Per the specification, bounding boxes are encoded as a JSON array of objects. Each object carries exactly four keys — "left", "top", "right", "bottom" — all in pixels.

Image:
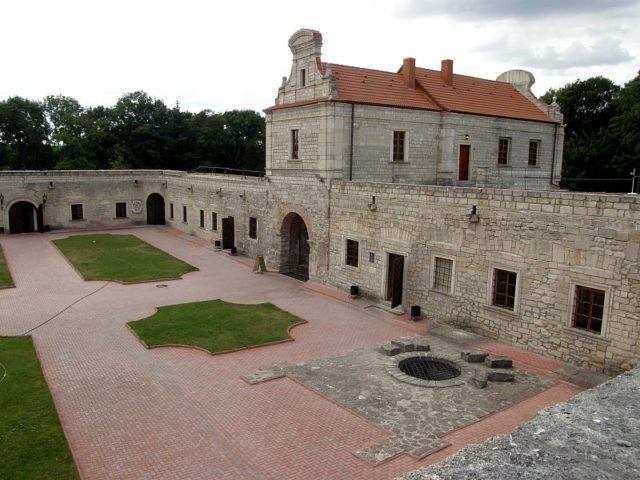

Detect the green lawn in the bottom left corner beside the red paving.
[{"left": 0, "top": 337, "right": 79, "bottom": 479}]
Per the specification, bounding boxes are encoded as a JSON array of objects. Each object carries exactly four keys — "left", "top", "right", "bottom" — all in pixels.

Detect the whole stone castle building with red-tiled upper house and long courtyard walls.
[{"left": 0, "top": 30, "right": 640, "bottom": 374}]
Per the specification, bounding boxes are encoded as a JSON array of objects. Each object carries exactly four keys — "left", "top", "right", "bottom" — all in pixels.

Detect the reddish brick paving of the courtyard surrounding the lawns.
[{"left": 0, "top": 227, "right": 577, "bottom": 480}]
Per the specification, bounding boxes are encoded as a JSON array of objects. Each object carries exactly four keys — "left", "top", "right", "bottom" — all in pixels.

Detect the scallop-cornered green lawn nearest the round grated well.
[{"left": 129, "top": 300, "right": 305, "bottom": 353}]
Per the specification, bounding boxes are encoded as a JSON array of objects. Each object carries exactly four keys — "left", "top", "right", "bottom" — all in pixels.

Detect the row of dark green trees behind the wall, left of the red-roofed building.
[{"left": 0, "top": 92, "right": 265, "bottom": 170}]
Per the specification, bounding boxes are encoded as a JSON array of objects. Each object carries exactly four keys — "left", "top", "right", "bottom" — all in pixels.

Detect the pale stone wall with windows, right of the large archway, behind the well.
[{"left": 328, "top": 182, "right": 640, "bottom": 373}]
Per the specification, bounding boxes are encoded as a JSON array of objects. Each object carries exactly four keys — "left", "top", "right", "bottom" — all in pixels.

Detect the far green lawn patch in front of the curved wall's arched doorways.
[{"left": 53, "top": 234, "right": 197, "bottom": 283}]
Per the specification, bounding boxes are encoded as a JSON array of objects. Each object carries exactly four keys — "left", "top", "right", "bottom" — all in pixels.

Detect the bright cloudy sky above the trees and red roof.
[{"left": 0, "top": 0, "right": 640, "bottom": 111}]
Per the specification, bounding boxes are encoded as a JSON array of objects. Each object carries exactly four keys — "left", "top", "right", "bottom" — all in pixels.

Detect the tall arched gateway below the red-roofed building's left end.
[{"left": 280, "top": 212, "right": 309, "bottom": 280}]
